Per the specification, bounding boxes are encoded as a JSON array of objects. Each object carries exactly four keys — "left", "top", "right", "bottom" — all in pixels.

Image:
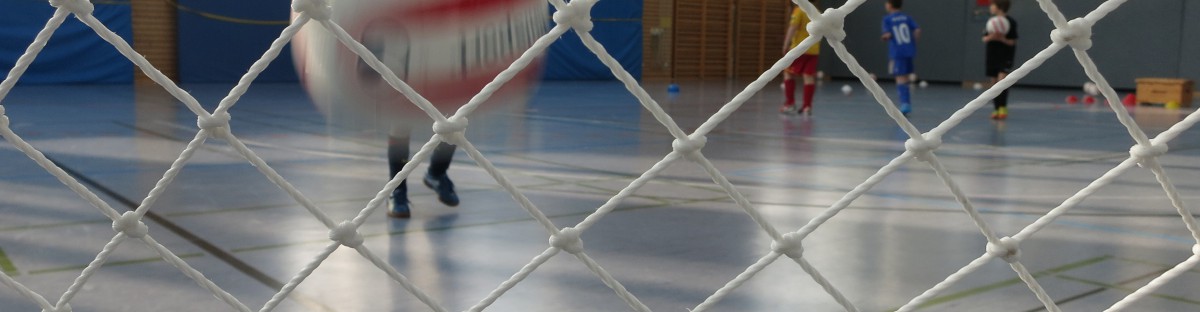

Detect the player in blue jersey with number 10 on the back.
[{"left": 883, "top": 0, "right": 920, "bottom": 115}]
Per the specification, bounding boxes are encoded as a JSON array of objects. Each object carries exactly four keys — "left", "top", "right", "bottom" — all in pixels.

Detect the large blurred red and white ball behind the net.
[{"left": 292, "top": 0, "right": 548, "bottom": 122}]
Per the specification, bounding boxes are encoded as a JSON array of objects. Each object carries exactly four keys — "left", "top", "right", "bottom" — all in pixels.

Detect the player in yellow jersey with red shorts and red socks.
[{"left": 779, "top": 0, "right": 821, "bottom": 115}]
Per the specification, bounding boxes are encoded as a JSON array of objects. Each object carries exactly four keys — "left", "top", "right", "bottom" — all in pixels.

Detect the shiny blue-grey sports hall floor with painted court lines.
[{"left": 0, "top": 82, "right": 1200, "bottom": 312}]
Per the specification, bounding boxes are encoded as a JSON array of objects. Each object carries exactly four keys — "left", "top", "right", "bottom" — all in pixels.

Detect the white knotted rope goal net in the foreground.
[{"left": 0, "top": 0, "right": 1200, "bottom": 312}]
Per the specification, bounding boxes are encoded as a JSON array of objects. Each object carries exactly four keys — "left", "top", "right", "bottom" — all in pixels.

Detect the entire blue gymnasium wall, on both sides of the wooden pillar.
[{"left": 0, "top": 0, "right": 643, "bottom": 83}]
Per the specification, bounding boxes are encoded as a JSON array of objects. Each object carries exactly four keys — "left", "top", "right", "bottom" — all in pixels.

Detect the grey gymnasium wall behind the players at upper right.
[{"left": 821, "top": 0, "right": 1200, "bottom": 89}]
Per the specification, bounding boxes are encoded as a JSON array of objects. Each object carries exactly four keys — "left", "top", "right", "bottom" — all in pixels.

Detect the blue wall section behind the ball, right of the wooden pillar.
[{"left": 168, "top": 0, "right": 642, "bottom": 83}]
